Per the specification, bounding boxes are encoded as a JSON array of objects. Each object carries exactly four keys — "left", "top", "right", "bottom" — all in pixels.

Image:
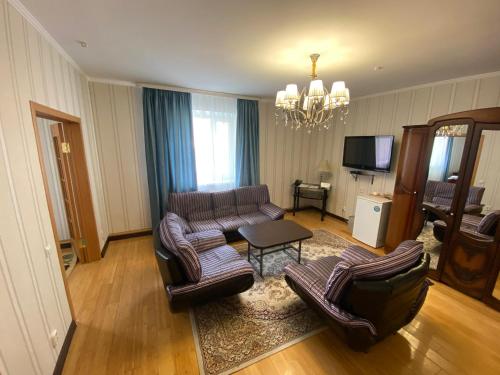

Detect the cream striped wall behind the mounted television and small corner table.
[{"left": 260, "top": 72, "right": 500, "bottom": 217}]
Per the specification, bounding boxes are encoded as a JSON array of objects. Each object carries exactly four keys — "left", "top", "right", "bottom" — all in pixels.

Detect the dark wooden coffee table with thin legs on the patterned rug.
[{"left": 238, "top": 220, "right": 313, "bottom": 276}]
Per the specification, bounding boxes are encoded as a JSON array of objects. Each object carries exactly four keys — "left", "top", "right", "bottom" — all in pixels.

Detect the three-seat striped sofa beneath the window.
[{"left": 168, "top": 185, "right": 285, "bottom": 240}]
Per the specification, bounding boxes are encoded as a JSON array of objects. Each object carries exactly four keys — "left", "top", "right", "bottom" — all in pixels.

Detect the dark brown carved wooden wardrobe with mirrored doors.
[{"left": 386, "top": 108, "right": 500, "bottom": 309}]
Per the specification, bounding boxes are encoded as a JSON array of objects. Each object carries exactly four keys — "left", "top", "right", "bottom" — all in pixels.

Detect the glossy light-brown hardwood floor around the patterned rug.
[{"left": 64, "top": 211, "right": 500, "bottom": 375}]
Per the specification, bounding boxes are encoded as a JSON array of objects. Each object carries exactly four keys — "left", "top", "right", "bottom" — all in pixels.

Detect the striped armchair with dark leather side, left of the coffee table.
[{"left": 153, "top": 212, "right": 254, "bottom": 312}]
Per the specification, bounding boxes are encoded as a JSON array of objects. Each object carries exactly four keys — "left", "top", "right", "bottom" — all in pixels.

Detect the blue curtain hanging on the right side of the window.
[{"left": 235, "top": 99, "right": 259, "bottom": 186}]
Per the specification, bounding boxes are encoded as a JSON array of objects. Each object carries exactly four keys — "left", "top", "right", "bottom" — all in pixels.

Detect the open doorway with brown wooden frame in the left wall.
[{"left": 31, "top": 102, "right": 101, "bottom": 279}]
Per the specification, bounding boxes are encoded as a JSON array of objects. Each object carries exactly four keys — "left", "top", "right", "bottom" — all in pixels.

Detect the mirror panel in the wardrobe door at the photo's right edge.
[{"left": 460, "top": 130, "right": 500, "bottom": 241}]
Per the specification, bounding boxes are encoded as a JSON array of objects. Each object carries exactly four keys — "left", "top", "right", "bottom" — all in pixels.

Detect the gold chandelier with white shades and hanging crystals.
[{"left": 275, "top": 53, "right": 349, "bottom": 133}]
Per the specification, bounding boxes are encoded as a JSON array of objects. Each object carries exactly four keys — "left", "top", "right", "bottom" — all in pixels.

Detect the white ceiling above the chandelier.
[{"left": 21, "top": 0, "right": 500, "bottom": 97}]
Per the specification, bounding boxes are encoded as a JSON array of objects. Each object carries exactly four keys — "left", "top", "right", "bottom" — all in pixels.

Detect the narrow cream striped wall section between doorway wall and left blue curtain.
[{"left": 90, "top": 82, "right": 151, "bottom": 233}]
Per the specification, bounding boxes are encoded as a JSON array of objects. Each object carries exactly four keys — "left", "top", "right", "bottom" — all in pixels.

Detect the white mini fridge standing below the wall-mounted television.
[{"left": 352, "top": 195, "right": 392, "bottom": 247}]
